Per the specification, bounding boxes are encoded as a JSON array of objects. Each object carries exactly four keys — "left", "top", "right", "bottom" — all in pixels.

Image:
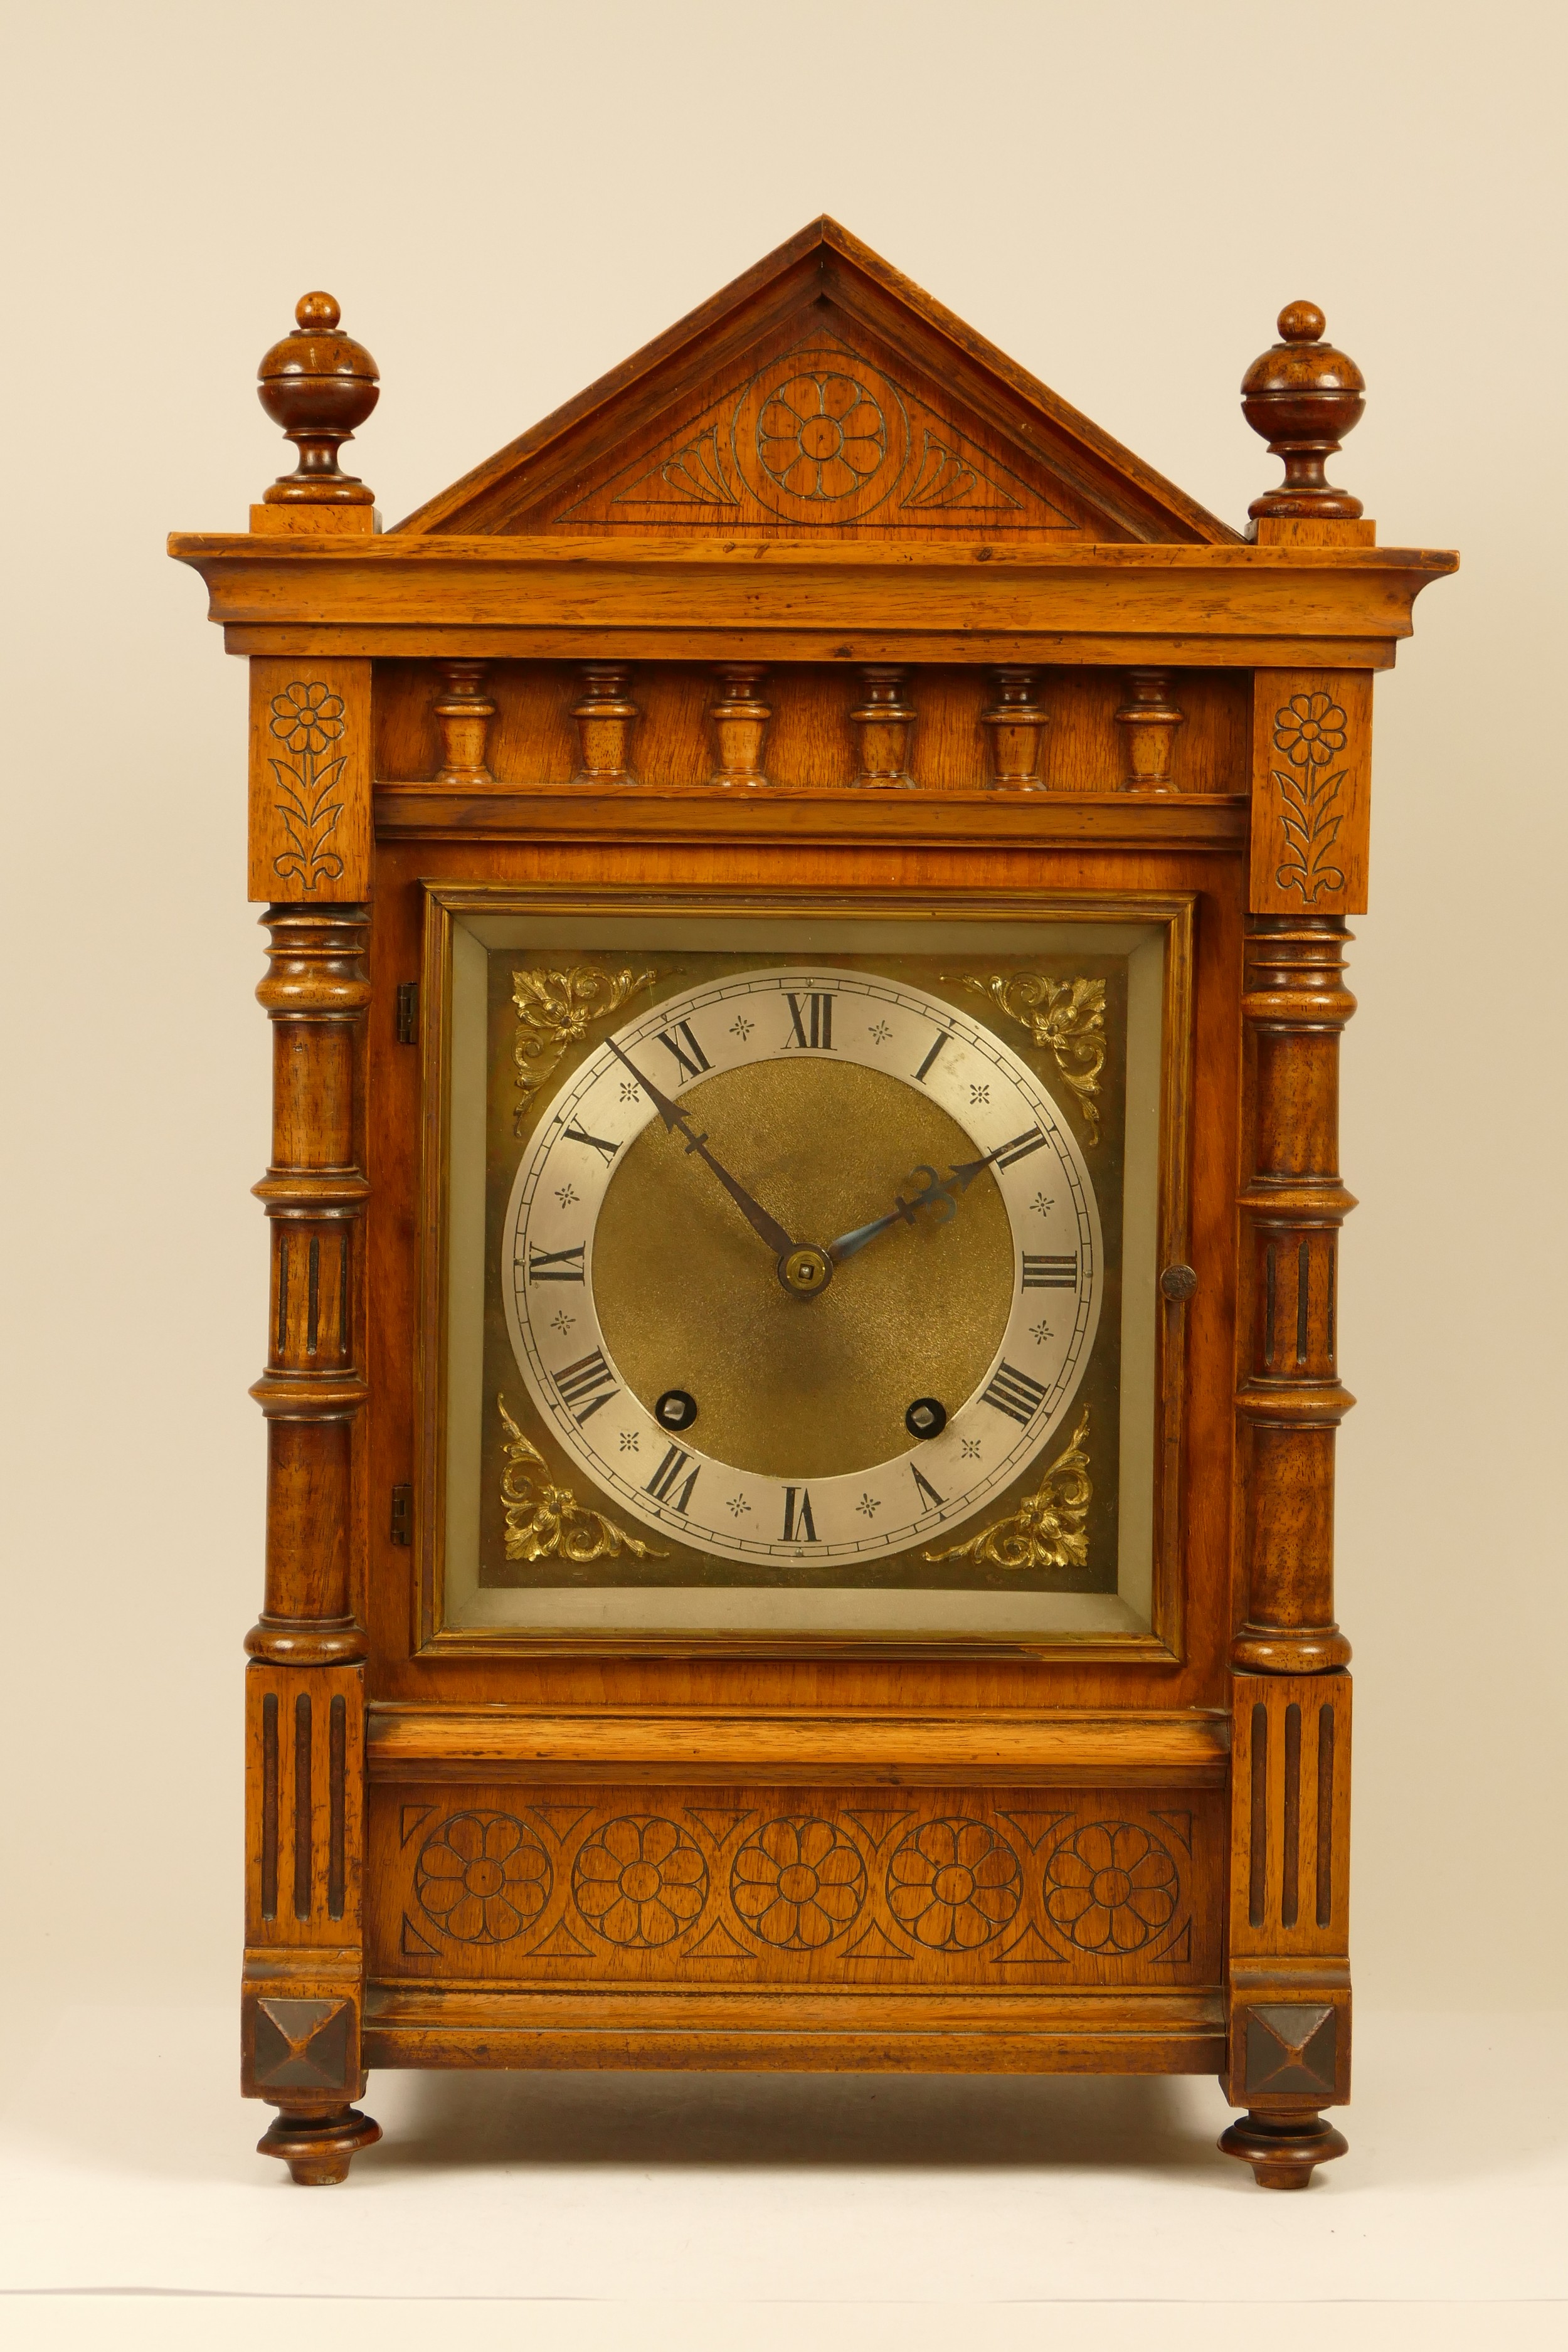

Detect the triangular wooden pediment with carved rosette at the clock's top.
[{"left": 400, "top": 219, "right": 1237, "bottom": 543}]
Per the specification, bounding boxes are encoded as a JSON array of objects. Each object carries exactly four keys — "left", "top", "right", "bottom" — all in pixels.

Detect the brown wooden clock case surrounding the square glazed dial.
[{"left": 172, "top": 221, "right": 1455, "bottom": 2188}]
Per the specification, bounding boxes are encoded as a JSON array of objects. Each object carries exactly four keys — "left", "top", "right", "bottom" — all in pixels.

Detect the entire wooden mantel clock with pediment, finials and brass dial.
[{"left": 172, "top": 221, "right": 1455, "bottom": 2188}]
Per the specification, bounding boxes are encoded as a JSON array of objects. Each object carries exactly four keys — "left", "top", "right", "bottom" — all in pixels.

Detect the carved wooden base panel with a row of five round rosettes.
[{"left": 369, "top": 1781, "right": 1225, "bottom": 1992}]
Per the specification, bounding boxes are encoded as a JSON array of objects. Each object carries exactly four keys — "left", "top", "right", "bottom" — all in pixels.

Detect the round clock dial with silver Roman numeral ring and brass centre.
[{"left": 503, "top": 967, "right": 1103, "bottom": 1564}]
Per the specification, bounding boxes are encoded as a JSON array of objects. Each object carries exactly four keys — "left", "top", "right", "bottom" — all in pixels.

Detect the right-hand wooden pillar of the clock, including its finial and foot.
[{"left": 1220, "top": 304, "right": 1375, "bottom": 2190}]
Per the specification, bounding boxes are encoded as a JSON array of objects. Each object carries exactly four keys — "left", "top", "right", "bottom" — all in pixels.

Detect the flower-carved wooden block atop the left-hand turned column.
[{"left": 249, "top": 654, "right": 371, "bottom": 906}]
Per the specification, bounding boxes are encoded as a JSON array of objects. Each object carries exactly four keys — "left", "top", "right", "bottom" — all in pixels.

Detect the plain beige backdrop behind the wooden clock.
[{"left": 0, "top": 0, "right": 1568, "bottom": 2018}]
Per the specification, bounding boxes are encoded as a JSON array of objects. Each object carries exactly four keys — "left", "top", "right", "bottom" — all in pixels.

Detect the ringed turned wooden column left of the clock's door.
[{"left": 247, "top": 906, "right": 369, "bottom": 1665}]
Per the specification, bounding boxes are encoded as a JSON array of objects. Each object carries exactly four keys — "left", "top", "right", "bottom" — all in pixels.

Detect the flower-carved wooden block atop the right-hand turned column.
[{"left": 1248, "top": 670, "right": 1373, "bottom": 915}]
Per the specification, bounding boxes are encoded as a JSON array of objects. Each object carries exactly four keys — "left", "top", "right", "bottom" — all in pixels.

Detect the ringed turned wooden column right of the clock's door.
[{"left": 1232, "top": 915, "right": 1357, "bottom": 1675}]
